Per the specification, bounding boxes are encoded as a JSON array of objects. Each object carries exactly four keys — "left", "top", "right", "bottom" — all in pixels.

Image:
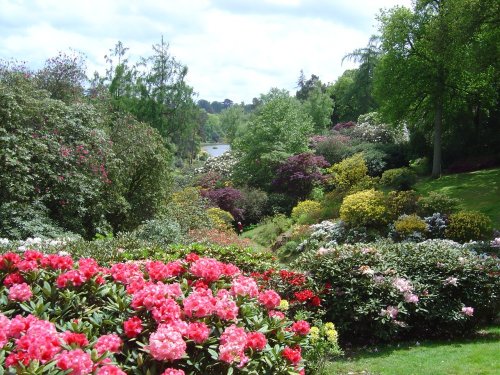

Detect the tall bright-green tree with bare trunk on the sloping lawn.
[{"left": 375, "top": 0, "right": 500, "bottom": 177}]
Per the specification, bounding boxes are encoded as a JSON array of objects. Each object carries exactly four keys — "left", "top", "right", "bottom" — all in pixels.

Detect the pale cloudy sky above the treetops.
[{"left": 0, "top": 0, "right": 411, "bottom": 103}]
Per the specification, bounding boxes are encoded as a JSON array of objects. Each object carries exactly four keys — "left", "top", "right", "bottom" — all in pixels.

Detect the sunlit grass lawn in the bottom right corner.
[{"left": 324, "top": 326, "right": 500, "bottom": 375}]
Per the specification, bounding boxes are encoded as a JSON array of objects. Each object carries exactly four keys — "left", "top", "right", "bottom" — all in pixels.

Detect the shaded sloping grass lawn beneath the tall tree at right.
[{"left": 414, "top": 168, "right": 500, "bottom": 229}]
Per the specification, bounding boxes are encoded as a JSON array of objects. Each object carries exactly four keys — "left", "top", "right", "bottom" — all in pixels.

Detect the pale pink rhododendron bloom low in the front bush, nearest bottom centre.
[{"left": 147, "top": 325, "right": 186, "bottom": 361}]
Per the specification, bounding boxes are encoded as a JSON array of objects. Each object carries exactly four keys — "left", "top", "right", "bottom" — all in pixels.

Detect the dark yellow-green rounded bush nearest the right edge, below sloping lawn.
[{"left": 445, "top": 211, "right": 491, "bottom": 242}]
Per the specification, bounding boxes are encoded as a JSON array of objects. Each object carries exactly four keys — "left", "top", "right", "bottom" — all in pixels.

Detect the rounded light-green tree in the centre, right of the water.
[{"left": 234, "top": 89, "right": 313, "bottom": 189}]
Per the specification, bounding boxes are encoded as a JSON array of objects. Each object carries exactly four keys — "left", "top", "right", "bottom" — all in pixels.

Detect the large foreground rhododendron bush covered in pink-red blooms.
[{"left": 0, "top": 250, "right": 310, "bottom": 375}]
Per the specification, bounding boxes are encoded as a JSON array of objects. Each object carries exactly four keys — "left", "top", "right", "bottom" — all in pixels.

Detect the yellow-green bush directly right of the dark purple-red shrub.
[{"left": 328, "top": 152, "right": 368, "bottom": 190}]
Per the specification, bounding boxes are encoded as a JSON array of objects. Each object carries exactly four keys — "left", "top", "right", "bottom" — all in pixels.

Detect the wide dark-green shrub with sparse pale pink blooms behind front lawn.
[{"left": 292, "top": 240, "right": 500, "bottom": 342}]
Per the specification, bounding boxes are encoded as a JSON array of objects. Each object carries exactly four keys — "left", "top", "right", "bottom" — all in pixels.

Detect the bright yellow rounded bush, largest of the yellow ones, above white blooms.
[{"left": 340, "top": 189, "right": 387, "bottom": 226}]
